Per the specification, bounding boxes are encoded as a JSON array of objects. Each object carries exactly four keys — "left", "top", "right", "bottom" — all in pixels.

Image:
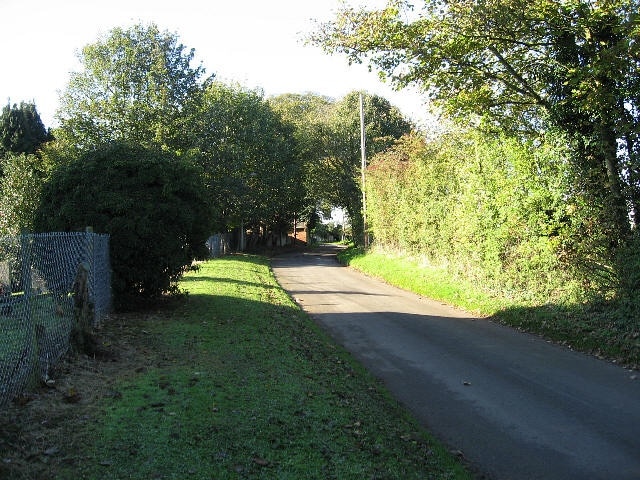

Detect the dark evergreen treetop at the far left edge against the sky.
[{"left": 0, "top": 102, "right": 50, "bottom": 157}]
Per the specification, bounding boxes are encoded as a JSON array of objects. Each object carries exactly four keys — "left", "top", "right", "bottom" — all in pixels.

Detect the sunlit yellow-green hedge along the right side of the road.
[{"left": 367, "top": 131, "right": 610, "bottom": 303}]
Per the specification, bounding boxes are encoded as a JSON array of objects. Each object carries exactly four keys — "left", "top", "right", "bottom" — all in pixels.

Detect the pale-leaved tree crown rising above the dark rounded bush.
[{"left": 58, "top": 24, "right": 205, "bottom": 149}]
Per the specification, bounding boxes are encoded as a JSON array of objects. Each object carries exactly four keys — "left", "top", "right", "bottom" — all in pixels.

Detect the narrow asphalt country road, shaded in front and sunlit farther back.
[{"left": 273, "top": 247, "right": 640, "bottom": 480}]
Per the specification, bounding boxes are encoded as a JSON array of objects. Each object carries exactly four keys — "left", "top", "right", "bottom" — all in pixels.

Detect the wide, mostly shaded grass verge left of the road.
[{"left": 55, "top": 255, "right": 471, "bottom": 480}]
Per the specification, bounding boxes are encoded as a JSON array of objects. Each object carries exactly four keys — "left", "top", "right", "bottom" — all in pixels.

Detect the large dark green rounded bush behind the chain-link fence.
[{"left": 35, "top": 143, "right": 212, "bottom": 308}]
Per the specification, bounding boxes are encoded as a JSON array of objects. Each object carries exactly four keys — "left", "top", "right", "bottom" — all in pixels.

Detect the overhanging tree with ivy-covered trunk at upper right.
[{"left": 312, "top": 0, "right": 640, "bottom": 240}]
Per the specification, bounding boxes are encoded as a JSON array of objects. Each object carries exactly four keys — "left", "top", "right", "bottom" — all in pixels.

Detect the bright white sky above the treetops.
[{"left": 0, "top": 0, "right": 428, "bottom": 127}]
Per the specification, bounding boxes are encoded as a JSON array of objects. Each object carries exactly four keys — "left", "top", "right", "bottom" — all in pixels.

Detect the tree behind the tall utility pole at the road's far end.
[{"left": 272, "top": 92, "right": 412, "bottom": 246}]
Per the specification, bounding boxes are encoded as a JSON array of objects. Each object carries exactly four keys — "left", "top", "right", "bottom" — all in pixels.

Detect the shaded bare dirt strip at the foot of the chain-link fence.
[{"left": 0, "top": 312, "right": 162, "bottom": 480}]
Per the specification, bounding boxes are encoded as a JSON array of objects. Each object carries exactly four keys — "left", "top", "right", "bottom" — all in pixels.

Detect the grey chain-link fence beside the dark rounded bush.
[{"left": 0, "top": 232, "right": 111, "bottom": 406}]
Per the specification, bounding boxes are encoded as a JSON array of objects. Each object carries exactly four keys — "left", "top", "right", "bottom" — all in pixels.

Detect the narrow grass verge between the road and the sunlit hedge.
[{"left": 338, "top": 247, "right": 640, "bottom": 369}]
